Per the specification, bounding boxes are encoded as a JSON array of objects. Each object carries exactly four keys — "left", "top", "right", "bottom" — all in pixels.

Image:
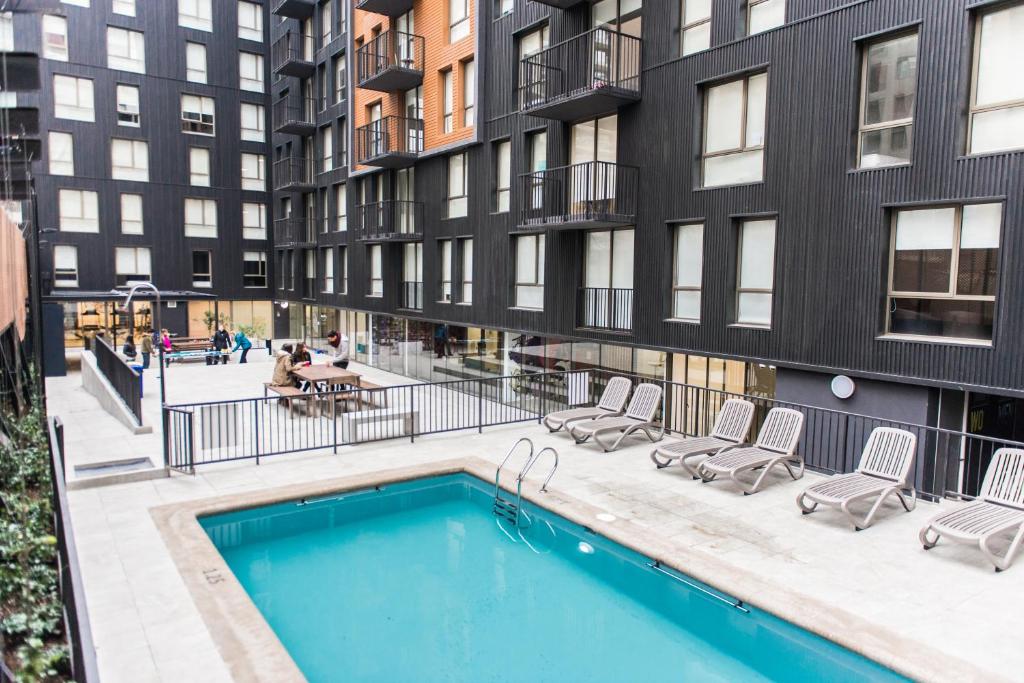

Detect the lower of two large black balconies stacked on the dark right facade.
[{"left": 516, "top": 161, "right": 640, "bottom": 230}]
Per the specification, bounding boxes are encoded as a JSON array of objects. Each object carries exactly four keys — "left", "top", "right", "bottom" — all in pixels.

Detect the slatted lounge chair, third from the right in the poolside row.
[{"left": 697, "top": 408, "right": 804, "bottom": 496}]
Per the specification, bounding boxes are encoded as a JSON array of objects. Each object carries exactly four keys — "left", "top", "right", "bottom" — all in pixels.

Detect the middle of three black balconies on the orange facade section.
[{"left": 355, "top": 31, "right": 423, "bottom": 92}]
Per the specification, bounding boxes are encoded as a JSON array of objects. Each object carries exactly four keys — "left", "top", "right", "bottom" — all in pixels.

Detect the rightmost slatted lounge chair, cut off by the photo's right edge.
[{"left": 919, "top": 449, "right": 1024, "bottom": 571}]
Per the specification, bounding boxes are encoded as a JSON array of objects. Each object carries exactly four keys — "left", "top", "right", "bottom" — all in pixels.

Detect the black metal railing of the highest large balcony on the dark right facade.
[{"left": 519, "top": 29, "right": 642, "bottom": 111}]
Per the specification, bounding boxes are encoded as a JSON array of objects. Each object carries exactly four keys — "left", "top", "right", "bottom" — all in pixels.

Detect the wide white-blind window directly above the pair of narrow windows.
[{"left": 702, "top": 74, "right": 768, "bottom": 187}]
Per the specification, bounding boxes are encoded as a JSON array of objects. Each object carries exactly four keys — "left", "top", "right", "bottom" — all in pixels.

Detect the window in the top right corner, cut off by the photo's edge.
[{"left": 968, "top": 4, "right": 1024, "bottom": 155}]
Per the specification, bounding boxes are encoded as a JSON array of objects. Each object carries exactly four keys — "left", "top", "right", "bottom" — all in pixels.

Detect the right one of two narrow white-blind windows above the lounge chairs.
[{"left": 736, "top": 220, "right": 775, "bottom": 328}]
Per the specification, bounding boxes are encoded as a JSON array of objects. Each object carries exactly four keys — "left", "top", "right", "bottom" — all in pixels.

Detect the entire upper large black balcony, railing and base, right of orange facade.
[{"left": 519, "top": 29, "right": 641, "bottom": 121}]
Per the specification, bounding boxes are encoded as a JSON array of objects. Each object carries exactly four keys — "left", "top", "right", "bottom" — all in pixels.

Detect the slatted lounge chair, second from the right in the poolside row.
[{"left": 797, "top": 427, "right": 918, "bottom": 531}]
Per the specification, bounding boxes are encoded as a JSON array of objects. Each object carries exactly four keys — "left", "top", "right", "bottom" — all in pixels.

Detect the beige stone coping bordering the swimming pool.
[{"left": 150, "top": 457, "right": 1010, "bottom": 682}]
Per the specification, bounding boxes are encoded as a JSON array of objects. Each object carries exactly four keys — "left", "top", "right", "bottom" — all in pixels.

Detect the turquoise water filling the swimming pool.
[{"left": 201, "top": 474, "right": 904, "bottom": 683}]
